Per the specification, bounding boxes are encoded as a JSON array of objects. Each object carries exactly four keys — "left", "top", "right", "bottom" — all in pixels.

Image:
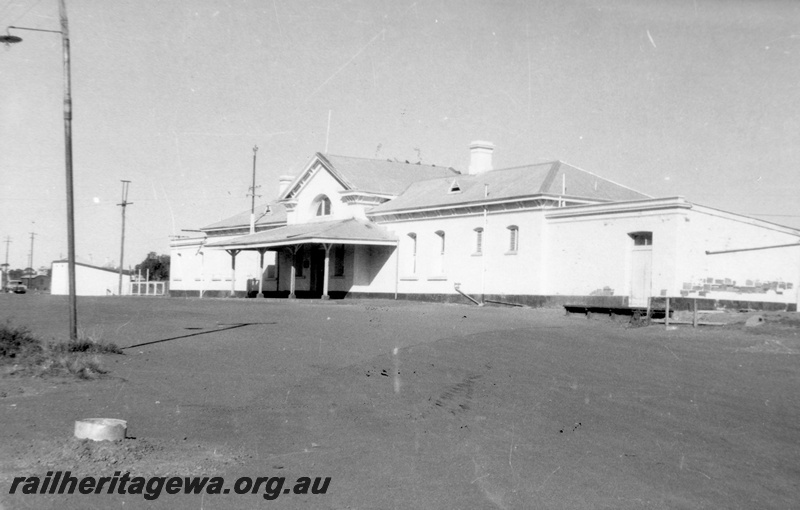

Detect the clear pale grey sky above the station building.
[{"left": 0, "top": 0, "right": 800, "bottom": 268}]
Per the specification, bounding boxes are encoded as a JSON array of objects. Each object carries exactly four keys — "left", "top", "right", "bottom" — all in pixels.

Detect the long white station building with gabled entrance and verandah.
[{"left": 170, "top": 142, "right": 800, "bottom": 310}]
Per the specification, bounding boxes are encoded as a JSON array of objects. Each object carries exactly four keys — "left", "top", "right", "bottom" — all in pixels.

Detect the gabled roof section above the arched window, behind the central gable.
[{"left": 283, "top": 152, "right": 460, "bottom": 197}]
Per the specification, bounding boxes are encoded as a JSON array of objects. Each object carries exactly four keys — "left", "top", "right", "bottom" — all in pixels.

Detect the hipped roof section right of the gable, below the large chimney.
[{"left": 370, "top": 161, "right": 651, "bottom": 214}]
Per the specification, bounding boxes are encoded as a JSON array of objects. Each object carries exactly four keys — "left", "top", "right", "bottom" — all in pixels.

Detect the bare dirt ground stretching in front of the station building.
[{"left": 0, "top": 295, "right": 800, "bottom": 509}]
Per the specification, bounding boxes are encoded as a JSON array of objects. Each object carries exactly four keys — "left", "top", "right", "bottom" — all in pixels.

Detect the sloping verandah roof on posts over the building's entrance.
[{"left": 206, "top": 218, "right": 397, "bottom": 250}]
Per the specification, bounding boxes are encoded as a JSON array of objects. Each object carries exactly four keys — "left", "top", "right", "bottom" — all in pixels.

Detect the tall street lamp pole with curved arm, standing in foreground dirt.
[{"left": 0, "top": 0, "right": 78, "bottom": 341}]
